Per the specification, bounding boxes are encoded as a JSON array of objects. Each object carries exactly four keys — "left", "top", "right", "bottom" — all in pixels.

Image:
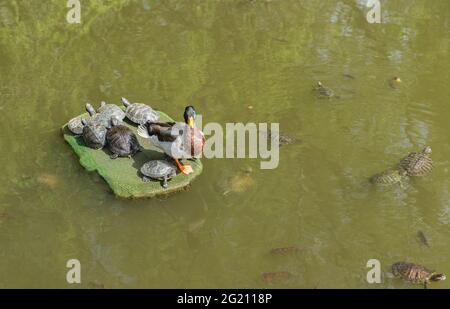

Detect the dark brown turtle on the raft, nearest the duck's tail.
[{"left": 106, "top": 117, "right": 141, "bottom": 159}]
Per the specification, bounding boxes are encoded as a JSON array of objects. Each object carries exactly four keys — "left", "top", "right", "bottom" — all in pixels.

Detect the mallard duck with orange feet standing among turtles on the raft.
[{"left": 138, "top": 106, "right": 205, "bottom": 175}]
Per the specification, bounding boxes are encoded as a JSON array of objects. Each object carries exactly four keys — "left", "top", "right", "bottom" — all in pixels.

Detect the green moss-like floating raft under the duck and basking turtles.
[{"left": 62, "top": 112, "right": 203, "bottom": 198}]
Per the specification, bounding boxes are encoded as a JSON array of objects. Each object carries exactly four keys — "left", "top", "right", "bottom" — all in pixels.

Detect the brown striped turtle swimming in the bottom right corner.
[{"left": 392, "top": 262, "right": 446, "bottom": 288}]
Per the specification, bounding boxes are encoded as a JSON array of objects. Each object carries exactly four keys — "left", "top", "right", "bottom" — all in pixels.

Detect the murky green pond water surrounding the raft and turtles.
[{"left": 0, "top": 0, "right": 450, "bottom": 288}]
